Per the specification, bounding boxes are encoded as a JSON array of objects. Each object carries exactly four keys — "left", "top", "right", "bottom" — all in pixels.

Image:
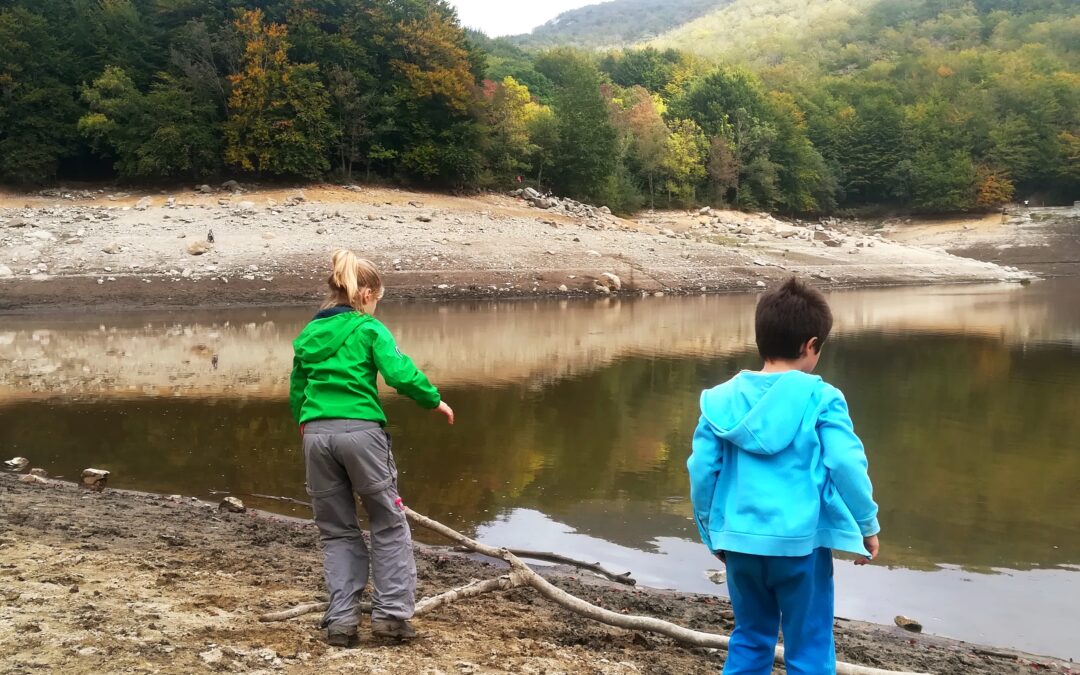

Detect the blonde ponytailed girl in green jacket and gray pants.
[{"left": 289, "top": 251, "right": 454, "bottom": 647}]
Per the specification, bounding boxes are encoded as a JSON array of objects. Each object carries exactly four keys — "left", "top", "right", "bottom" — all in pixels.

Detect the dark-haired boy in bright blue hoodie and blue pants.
[{"left": 687, "top": 278, "right": 880, "bottom": 675}]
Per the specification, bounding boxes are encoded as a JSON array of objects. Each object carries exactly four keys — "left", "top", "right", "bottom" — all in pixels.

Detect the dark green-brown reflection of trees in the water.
[{"left": 0, "top": 334, "right": 1080, "bottom": 568}]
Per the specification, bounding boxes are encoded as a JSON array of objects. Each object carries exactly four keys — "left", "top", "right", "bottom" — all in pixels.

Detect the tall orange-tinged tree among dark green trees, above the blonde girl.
[{"left": 225, "top": 10, "right": 339, "bottom": 178}]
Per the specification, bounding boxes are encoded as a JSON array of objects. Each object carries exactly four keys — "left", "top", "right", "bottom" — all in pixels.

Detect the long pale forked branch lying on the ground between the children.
[{"left": 260, "top": 508, "right": 923, "bottom": 675}]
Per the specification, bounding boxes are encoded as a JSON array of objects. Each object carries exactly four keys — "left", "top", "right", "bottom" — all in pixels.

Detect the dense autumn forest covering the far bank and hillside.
[{"left": 0, "top": 0, "right": 1080, "bottom": 214}]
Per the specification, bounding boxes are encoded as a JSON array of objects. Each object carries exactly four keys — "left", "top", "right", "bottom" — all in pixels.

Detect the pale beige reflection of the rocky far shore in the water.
[{"left": 0, "top": 282, "right": 1080, "bottom": 401}]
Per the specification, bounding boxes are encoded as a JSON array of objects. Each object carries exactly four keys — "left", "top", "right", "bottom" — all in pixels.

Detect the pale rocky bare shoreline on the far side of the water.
[{"left": 0, "top": 186, "right": 1024, "bottom": 310}]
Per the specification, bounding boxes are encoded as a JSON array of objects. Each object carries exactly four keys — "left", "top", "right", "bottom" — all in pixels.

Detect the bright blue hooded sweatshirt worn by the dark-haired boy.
[{"left": 687, "top": 370, "right": 880, "bottom": 556}]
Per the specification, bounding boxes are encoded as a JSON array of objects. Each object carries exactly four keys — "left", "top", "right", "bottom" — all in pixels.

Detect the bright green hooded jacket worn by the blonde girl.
[{"left": 288, "top": 308, "right": 442, "bottom": 426}]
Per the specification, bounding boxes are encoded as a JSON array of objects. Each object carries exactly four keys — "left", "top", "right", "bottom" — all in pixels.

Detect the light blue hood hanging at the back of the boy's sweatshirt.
[{"left": 701, "top": 370, "right": 822, "bottom": 455}]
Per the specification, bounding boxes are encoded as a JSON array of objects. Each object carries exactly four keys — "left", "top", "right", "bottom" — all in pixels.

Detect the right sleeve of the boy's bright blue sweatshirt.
[{"left": 818, "top": 389, "right": 881, "bottom": 537}]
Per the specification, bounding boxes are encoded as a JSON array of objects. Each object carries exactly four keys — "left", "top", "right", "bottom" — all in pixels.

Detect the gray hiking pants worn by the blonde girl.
[{"left": 303, "top": 419, "right": 416, "bottom": 630}]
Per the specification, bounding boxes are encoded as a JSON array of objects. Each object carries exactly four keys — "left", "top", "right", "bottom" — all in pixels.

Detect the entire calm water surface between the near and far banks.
[{"left": 0, "top": 280, "right": 1080, "bottom": 658}]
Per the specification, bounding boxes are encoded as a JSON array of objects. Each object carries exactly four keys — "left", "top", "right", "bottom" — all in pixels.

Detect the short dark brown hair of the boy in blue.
[{"left": 754, "top": 276, "right": 833, "bottom": 361}]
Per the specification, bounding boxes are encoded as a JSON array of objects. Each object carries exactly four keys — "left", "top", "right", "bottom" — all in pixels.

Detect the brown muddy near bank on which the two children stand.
[{"left": 0, "top": 474, "right": 1075, "bottom": 674}]
